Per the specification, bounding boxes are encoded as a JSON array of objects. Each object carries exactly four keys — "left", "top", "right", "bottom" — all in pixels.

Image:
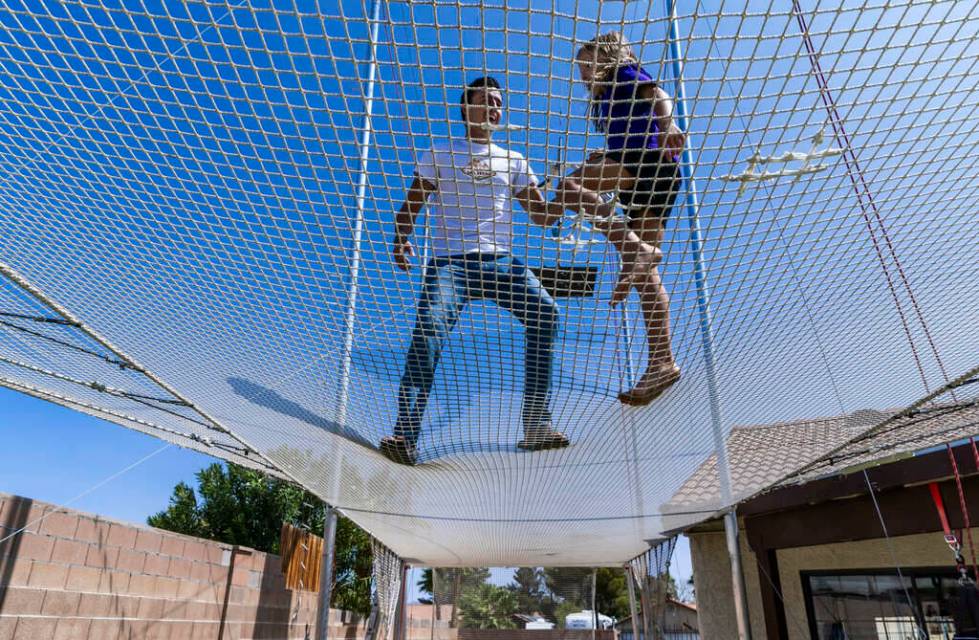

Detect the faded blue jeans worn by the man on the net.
[{"left": 394, "top": 253, "right": 558, "bottom": 443}]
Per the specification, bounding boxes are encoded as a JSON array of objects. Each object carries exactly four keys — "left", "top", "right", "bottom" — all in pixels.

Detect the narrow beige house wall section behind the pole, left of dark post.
[{"left": 687, "top": 529, "right": 765, "bottom": 640}]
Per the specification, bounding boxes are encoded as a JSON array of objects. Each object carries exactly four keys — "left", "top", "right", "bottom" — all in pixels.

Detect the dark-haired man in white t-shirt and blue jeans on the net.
[{"left": 381, "top": 77, "right": 569, "bottom": 464}]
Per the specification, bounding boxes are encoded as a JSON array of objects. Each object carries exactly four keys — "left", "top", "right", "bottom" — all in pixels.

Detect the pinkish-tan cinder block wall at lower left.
[{"left": 0, "top": 493, "right": 363, "bottom": 640}]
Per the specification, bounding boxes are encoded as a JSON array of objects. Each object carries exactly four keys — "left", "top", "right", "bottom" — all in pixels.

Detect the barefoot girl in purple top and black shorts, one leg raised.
[{"left": 564, "top": 32, "right": 685, "bottom": 405}]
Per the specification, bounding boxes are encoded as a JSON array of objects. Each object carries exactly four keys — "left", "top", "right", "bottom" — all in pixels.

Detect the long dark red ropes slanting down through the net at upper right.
[{"left": 792, "top": 0, "right": 956, "bottom": 400}]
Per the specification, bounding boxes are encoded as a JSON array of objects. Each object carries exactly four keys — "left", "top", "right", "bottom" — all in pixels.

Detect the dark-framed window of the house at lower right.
[{"left": 802, "top": 568, "right": 958, "bottom": 640}]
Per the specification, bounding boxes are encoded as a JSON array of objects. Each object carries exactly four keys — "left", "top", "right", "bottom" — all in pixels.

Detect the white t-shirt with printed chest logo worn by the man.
[{"left": 415, "top": 139, "right": 537, "bottom": 256}]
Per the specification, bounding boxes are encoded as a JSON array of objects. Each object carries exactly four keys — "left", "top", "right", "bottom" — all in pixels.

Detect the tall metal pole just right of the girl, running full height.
[{"left": 666, "top": 0, "right": 751, "bottom": 640}]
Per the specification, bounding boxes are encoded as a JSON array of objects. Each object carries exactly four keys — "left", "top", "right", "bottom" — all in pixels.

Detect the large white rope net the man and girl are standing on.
[{"left": 0, "top": 0, "right": 979, "bottom": 567}]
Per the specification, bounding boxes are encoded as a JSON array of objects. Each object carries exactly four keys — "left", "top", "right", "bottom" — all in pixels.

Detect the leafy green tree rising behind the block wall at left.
[{"left": 146, "top": 463, "right": 372, "bottom": 615}]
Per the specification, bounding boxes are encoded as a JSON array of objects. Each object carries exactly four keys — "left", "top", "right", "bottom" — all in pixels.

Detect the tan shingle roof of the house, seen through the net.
[{"left": 662, "top": 401, "right": 979, "bottom": 531}]
